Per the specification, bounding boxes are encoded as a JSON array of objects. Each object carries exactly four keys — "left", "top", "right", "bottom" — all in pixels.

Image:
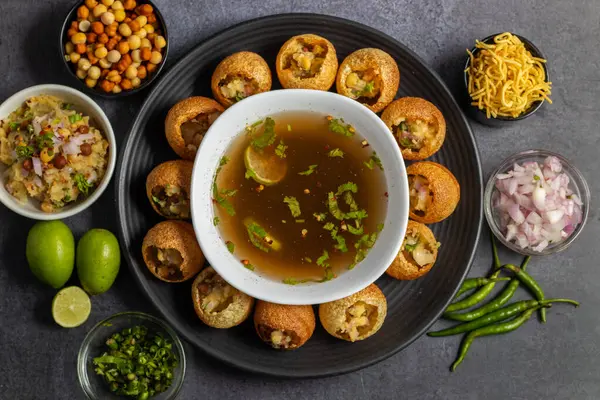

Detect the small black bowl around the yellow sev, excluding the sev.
[{"left": 463, "top": 33, "right": 550, "bottom": 128}]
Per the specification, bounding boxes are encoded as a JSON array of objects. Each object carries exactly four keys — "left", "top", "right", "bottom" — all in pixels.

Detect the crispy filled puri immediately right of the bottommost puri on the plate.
[{"left": 319, "top": 283, "right": 387, "bottom": 342}]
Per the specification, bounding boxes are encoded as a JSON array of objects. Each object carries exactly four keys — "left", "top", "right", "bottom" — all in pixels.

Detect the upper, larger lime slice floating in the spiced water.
[{"left": 244, "top": 146, "right": 287, "bottom": 186}]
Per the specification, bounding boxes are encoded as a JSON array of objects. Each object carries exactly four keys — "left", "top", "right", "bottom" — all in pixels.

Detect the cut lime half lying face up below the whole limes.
[{"left": 52, "top": 286, "right": 92, "bottom": 328}]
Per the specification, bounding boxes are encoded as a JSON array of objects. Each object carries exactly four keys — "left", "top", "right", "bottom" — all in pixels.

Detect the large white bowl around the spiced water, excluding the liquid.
[{"left": 191, "top": 89, "right": 409, "bottom": 304}]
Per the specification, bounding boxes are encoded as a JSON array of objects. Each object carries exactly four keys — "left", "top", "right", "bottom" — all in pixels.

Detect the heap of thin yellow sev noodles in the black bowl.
[{"left": 465, "top": 32, "right": 552, "bottom": 118}]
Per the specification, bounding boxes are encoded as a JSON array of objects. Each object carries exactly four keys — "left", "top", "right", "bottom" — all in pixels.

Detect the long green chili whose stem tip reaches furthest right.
[{"left": 427, "top": 299, "right": 579, "bottom": 337}]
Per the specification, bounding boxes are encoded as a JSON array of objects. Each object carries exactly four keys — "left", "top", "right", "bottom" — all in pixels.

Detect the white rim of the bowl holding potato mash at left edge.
[{"left": 0, "top": 84, "right": 117, "bottom": 221}]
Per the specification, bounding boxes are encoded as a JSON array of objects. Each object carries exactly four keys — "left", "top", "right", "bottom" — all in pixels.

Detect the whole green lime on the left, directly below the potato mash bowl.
[{"left": 25, "top": 221, "right": 75, "bottom": 289}]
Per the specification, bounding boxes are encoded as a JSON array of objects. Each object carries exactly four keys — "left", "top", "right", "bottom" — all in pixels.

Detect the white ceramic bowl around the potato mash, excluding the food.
[{"left": 0, "top": 85, "right": 117, "bottom": 220}]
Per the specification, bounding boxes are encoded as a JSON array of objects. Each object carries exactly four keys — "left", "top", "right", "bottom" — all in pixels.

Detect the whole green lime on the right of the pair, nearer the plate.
[{"left": 76, "top": 229, "right": 121, "bottom": 294}]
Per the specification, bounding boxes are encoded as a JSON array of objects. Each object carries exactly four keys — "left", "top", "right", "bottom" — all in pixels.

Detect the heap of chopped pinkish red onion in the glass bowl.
[{"left": 494, "top": 157, "right": 583, "bottom": 252}]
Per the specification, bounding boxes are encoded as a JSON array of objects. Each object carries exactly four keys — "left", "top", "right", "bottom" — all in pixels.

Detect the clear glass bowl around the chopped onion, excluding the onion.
[{"left": 483, "top": 150, "right": 590, "bottom": 256}]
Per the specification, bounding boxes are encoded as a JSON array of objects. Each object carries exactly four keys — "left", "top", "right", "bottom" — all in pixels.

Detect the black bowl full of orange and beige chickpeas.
[{"left": 60, "top": 0, "right": 169, "bottom": 98}]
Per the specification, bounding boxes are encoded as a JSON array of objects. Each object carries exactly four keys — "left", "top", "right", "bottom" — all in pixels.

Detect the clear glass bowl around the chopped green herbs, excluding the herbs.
[{"left": 77, "top": 312, "right": 185, "bottom": 400}]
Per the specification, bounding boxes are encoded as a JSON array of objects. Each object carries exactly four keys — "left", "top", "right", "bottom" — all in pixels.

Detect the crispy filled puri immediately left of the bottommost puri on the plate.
[{"left": 192, "top": 267, "right": 254, "bottom": 329}]
